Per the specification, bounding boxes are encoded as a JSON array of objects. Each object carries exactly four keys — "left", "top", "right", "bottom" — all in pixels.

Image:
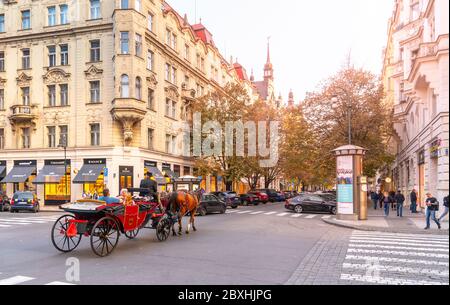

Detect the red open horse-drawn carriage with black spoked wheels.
[{"left": 51, "top": 189, "right": 174, "bottom": 257}]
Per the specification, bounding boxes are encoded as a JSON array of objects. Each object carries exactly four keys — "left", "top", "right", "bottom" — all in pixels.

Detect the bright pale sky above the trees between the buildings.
[{"left": 167, "top": 0, "right": 395, "bottom": 101}]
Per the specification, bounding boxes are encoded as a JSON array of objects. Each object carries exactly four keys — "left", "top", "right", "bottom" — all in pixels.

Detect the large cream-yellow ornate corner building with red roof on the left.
[{"left": 0, "top": 0, "right": 255, "bottom": 204}]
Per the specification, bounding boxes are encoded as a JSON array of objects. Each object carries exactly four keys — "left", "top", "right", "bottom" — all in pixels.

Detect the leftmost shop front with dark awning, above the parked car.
[{"left": 2, "top": 160, "right": 37, "bottom": 193}]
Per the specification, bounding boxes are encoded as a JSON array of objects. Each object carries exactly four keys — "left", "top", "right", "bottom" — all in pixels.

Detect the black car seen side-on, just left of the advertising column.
[{"left": 285, "top": 194, "right": 337, "bottom": 215}]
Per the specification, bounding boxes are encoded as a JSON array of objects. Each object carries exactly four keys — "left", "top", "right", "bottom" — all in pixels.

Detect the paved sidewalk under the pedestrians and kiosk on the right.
[{"left": 323, "top": 210, "right": 449, "bottom": 235}]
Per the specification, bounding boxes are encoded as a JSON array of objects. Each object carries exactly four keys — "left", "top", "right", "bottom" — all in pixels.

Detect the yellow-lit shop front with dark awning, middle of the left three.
[{"left": 33, "top": 160, "right": 71, "bottom": 205}]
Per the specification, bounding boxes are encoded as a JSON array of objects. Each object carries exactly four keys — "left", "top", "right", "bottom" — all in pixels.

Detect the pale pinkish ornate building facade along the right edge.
[{"left": 383, "top": 0, "right": 449, "bottom": 205}]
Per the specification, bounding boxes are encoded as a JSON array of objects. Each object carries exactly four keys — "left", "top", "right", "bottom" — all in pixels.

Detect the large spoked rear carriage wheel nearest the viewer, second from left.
[{"left": 91, "top": 217, "right": 120, "bottom": 257}]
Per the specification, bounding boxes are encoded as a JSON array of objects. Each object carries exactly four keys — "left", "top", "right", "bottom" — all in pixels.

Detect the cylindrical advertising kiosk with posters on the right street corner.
[{"left": 334, "top": 145, "right": 367, "bottom": 220}]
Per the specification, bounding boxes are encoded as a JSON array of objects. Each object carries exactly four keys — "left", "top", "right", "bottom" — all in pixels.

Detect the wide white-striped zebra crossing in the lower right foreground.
[{"left": 340, "top": 231, "right": 449, "bottom": 285}]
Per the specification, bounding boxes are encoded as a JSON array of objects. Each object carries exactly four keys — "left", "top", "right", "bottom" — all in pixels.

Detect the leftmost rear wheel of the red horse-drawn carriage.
[{"left": 51, "top": 215, "right": 82, "bottom": 253}]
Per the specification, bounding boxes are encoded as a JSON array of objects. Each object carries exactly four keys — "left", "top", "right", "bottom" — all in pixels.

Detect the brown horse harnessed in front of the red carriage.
[{"left": 167, "top": 191, "right": 200, "bottom": 236}]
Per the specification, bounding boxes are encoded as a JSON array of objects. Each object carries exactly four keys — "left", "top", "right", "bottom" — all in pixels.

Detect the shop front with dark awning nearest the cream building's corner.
[{"left": 73, "top": 159, "right": 106, "bottom": 198}]
